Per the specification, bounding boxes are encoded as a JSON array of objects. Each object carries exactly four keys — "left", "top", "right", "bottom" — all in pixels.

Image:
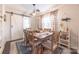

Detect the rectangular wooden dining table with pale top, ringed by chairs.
[{"left": 29, "top": 32, "right": 53, "bottom": 53}]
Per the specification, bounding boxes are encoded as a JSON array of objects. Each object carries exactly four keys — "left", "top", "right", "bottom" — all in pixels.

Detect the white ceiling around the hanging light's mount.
[{"left": 2, "top": 4, "right": 56, "bottom": 14}]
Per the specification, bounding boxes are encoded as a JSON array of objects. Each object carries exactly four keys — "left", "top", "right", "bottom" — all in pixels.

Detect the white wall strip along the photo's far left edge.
[{"left": 0, "top": 5, "right": 6, "bottom": 53}]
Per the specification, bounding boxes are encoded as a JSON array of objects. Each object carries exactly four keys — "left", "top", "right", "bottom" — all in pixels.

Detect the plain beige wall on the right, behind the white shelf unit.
[{"left": 58, "top": 5, "right": 79, "bottom": 49}]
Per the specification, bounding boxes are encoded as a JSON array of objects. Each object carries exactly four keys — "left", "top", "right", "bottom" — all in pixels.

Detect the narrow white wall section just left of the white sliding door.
[{"left": 3, "top": 13, "right": 10, "bottom": 41}]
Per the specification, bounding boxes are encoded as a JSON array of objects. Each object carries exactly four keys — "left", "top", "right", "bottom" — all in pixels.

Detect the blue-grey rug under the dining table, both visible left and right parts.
[{"left": 16, "top": 42, "right": 63, "bottom": 54}]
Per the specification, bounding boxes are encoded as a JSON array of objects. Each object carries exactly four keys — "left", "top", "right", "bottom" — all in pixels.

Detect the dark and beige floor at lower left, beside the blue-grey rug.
[{"left": 2, "top": 39, "right": 22, "bottom": 54}]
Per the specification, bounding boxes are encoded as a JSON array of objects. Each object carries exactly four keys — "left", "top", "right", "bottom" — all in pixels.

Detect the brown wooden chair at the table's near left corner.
[{"left": 27, "top": 32, "right": 41, "bottom": 54}]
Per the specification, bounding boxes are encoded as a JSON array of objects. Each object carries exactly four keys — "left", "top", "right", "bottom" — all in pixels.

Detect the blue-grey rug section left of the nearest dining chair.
[{"left": 16, "top": 41, "right": 32, "bottom": 54}]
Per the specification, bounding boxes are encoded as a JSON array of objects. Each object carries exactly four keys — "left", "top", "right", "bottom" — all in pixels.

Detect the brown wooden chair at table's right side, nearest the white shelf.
[{"left": 42, "top": 32, "right": 60, "bottom": 53}]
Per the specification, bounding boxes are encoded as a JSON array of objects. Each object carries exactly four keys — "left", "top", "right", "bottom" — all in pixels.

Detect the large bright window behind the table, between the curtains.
[{"left": 42, "top": 15, "right": 53, "bottom": 29}]
